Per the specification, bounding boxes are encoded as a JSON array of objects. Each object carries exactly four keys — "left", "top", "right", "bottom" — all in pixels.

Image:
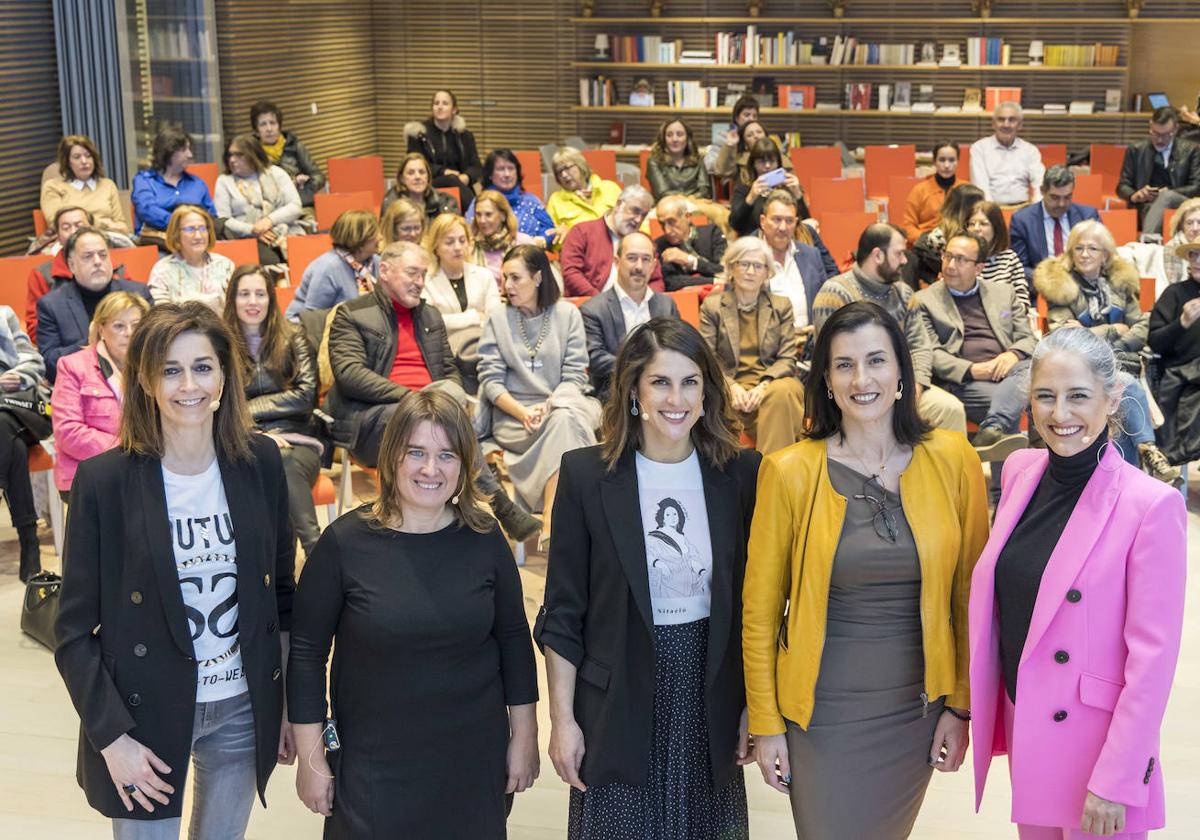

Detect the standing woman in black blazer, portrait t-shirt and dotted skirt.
[{"left": 534, "top": 318, "right": 760, "bottom": 840}]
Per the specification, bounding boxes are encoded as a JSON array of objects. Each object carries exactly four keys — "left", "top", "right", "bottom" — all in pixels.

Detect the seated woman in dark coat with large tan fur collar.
[{"left": 1033, "top": 221, "right": 1180, "bottom": 484}]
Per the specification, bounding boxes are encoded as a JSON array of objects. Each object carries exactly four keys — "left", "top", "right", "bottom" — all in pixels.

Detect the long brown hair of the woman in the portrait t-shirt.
[{"left": 600, "top": 317, "right": 740, "bottom": 473}]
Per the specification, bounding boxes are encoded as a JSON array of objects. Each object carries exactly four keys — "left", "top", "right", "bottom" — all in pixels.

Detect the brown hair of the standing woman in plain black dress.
[{"left": 371, "top": 389, "right": 496, "bottom": 534}]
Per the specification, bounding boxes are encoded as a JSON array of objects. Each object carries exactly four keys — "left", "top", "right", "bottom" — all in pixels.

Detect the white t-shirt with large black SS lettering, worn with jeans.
[{"left": 162, "top": 461, "right": 248, "bottom": 703}]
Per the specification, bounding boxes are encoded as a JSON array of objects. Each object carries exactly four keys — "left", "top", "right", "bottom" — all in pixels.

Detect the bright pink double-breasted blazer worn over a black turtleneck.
[{"left": 968, "top": 446, "right": 1187, "bottom": 832}]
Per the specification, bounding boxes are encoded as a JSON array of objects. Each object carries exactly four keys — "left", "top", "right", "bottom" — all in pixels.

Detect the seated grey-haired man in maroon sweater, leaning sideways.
[{"left": 559, "top": 184, "right": 665, "bottom": 298}]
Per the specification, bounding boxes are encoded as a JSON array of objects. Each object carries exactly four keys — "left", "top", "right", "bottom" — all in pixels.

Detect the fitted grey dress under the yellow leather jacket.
[{"left": 787, "top": 458, "right": 942, "bottom": 840}]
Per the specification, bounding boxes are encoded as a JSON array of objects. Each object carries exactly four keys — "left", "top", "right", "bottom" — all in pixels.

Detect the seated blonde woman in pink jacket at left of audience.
[{"left": 50, "top": 292, "right": 150, "bottom": 499}]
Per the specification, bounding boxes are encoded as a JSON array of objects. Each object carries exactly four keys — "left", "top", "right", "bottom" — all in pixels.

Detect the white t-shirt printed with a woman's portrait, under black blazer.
[{"left": 637, "top": 452, "right": 713, "bottom": 624}]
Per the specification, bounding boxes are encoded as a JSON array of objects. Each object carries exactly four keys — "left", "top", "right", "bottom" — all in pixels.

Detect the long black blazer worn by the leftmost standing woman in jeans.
[{"left": 54, "top": 434, "right": 295, "bottom": 820}]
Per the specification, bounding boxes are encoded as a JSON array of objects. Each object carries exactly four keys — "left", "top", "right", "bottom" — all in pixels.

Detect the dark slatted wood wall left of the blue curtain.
[{"left": 0, "top": 0, "right": 62, "bottom": 256}]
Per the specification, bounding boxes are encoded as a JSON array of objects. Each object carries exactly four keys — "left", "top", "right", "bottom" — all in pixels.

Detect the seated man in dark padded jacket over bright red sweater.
[{"left": 325, "top": 237, "right": 541, "bottom": 540}]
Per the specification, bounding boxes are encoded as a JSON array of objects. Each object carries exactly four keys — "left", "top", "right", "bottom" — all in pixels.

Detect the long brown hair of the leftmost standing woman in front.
[{"left": 120, "top": 300, "right": 254, "bottom": 461}]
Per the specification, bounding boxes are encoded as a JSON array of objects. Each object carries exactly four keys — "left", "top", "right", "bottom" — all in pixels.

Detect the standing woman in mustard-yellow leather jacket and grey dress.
[{"left": 742, "top": 301, "right": 988, "bottom": 840}]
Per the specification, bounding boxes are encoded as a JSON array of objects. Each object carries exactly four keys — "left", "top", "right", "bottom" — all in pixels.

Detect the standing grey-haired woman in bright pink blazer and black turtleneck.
[{"left": 968, "top": 328, "right": 1187, "bottom": 840}]
